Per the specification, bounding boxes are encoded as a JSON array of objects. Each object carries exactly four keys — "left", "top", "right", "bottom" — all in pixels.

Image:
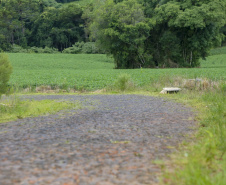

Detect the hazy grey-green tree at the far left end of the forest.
[{"left": 0, "top": 0, "right": 39, "bottom": 50}]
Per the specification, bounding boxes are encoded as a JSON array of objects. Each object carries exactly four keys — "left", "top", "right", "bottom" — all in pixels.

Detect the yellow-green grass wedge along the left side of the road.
[{"left": 0, "top": 96, "right": 81, "bottom": 123}]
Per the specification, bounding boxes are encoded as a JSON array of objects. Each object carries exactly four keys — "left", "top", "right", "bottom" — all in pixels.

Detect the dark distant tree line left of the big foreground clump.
[{"left": 0, "top": 0, "right": 85, "bottom": 51}]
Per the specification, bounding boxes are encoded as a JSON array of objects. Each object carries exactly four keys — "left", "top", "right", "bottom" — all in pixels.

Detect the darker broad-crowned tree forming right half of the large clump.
[{"left": 148, "top": 0, "right": 226, "bottom": 67}]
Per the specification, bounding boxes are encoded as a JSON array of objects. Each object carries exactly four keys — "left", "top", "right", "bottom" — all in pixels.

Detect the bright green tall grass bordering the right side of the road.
[{"left": 159, "top": 83, "right": 226, "bottom": 185}]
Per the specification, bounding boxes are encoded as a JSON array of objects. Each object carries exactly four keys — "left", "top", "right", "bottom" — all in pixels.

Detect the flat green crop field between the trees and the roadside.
[{"left": 8, "top": 53, "right": 226, "bottom": 90}]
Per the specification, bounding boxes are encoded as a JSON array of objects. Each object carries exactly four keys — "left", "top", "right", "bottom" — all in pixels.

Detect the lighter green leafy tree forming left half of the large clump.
[{"left": 90, "top": 0, "right": 150, "bottom": 68}]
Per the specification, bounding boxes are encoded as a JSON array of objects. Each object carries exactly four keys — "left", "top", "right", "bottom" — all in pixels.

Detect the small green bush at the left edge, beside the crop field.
[{"left": 0, "top": 53, "right": 12, "bottom": 97}]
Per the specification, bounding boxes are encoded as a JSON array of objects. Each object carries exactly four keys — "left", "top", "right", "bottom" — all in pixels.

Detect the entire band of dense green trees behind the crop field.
[{"left": 0, "top": 0, "right": 226, "bottom": 68}]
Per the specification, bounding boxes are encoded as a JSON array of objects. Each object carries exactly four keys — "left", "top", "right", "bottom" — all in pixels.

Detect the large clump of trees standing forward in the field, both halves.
[{"left": 90, "top": 0, "right": 226, "bottom": 68}]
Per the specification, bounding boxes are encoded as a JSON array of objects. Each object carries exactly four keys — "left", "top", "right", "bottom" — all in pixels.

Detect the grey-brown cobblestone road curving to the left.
[{"left": 0, "top": 95, "right": 194, "bottom": 185}]
